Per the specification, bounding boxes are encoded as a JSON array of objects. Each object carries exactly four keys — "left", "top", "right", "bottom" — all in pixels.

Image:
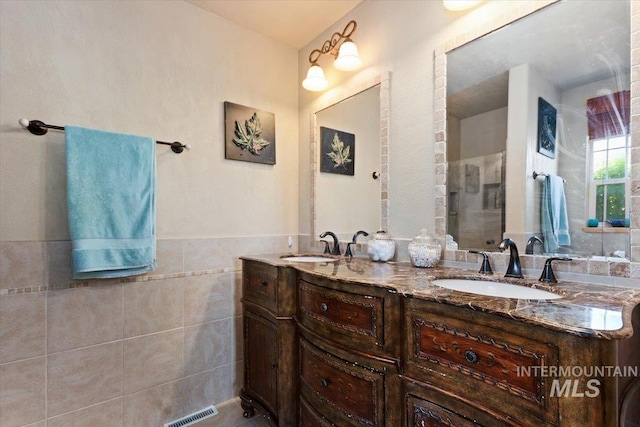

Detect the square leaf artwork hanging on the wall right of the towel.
[{"left": 224, "top": 101, "right": 276, "bottom": 165}]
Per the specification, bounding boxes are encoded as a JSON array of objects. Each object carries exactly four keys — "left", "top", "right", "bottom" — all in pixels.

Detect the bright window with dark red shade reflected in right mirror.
[{"left": 587, "top": 91, "right": 631, "bottom": 222}]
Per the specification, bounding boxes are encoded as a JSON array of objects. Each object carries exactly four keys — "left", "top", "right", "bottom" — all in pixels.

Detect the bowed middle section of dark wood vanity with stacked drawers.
[{"left": 298, "top": 273, "right": 402, "bottom": 427}]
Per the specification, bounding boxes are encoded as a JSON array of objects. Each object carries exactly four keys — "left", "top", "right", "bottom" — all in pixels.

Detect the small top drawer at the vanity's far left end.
[{"left": 242, "top": 261, "right": 278, "bottom": 312}]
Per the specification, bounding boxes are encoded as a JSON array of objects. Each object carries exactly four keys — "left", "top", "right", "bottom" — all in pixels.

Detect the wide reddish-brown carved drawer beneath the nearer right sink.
[{"left": 405, "top": 300, "right": 558, "bottom": 424}]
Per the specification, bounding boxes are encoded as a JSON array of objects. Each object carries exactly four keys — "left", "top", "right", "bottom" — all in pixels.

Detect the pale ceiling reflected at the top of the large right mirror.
[{"left": 447, "top": 1, "right": 631, "bottom": 118}]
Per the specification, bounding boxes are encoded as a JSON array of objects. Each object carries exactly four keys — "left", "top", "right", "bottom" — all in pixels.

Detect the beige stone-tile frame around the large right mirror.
[{"left": 434, "top": 0, "right": 640, "bottom": 278}]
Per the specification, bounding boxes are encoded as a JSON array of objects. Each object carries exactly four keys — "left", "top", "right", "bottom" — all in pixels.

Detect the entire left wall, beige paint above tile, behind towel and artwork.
[{"left": 0, "top": 0, "right": 298, "bottom": 427}]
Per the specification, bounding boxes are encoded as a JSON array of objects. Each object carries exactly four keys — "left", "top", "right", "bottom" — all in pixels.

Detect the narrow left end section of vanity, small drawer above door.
[{"left": 240, "top": 260, "right": 298, "bottom": 427}]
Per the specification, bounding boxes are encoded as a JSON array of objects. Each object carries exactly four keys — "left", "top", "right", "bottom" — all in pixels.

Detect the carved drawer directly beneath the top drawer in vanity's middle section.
[{"left": 300, "top": 339, "right": 385, "bottom": 426}]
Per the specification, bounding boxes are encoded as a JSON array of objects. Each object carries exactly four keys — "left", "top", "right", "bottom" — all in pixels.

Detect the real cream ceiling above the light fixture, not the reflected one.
[{"left": 185, "top": 0, "right": 364, "bottom": 50}]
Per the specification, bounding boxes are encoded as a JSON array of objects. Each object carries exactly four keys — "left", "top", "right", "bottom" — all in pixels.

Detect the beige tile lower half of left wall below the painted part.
[{"left": 0, "top": 236, "right": 288, "bottom": 427}]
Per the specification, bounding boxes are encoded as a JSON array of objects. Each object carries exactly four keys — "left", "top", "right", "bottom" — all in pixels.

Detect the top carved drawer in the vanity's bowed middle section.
[{"left": 298, "top": 280, "right": 384, "bottom": 347}]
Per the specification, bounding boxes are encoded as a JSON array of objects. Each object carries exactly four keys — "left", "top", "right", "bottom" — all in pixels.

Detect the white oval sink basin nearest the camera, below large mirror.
[{"left": 432, "top": 279, "right": 562, "bottom": 299}]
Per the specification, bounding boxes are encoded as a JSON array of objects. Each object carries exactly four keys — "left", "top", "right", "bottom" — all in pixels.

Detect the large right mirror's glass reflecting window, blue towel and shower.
[{"left": 446, "top": 1, "right": 631, "bottom": 258}]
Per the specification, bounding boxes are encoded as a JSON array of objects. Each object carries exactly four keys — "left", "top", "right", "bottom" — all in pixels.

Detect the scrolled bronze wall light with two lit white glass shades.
[{"left": 302, "top": 21, "right": 362, "bottom": 92}]
